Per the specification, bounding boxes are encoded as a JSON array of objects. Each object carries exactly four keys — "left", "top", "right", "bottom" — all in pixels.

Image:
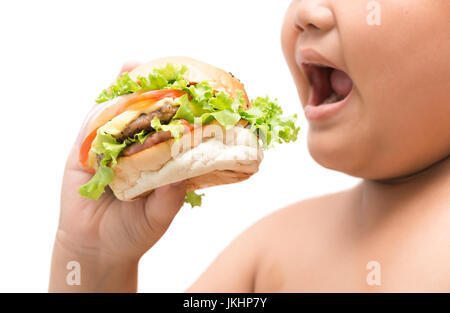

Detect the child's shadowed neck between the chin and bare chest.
[{"left": 355, "top": 156, "right": 450, "bottom": 222}]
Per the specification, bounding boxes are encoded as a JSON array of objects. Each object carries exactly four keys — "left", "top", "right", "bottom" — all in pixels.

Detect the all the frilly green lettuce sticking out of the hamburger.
[{"left": 79, "top": 63, "right": 300, "bottom": 202}]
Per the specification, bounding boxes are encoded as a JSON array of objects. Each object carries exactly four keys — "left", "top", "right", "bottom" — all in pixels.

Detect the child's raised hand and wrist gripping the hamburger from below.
[{"left": 50, "top": 62, "right": 186, "bottom": 291}]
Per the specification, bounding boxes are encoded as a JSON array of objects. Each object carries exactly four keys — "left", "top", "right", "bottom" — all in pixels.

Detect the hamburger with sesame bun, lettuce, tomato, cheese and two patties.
[{"left": 79, "top": 57, "right": 299, "bottom": 206}]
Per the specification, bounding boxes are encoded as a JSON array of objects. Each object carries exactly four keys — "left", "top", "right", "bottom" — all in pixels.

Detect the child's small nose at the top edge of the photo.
[{"left": 295, "top": 0, "right": 335, "bottom": 32}]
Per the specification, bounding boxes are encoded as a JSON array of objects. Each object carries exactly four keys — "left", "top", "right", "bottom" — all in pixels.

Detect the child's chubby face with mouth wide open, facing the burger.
[{"left": 282, "top": 0, "right": 450, "bottom": 179}]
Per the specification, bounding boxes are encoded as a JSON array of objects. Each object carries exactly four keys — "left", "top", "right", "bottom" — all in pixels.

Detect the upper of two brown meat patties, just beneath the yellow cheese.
[{"left": 116, "top": 101, "right": 178, "bottom": 142}]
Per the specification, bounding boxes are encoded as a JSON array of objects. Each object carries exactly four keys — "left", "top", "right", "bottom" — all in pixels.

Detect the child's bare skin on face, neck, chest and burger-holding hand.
[{"left": 50, "top": 0, "right": 450, "bottom": 292}]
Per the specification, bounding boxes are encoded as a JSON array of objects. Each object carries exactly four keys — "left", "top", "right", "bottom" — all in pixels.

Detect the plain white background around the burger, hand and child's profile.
[{"left": 0, "top": 0, "right": 357, "bottom": 292}]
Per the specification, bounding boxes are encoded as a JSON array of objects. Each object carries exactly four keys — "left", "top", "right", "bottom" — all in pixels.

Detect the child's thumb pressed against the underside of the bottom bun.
[{"left": 145, "top": 182, "right": 186, "bottom": 231}]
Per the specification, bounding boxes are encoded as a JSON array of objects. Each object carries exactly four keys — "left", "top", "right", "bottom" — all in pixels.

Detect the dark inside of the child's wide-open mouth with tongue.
[{"left": 302, "top": 63, "right": 353, "bottom": 106}]
